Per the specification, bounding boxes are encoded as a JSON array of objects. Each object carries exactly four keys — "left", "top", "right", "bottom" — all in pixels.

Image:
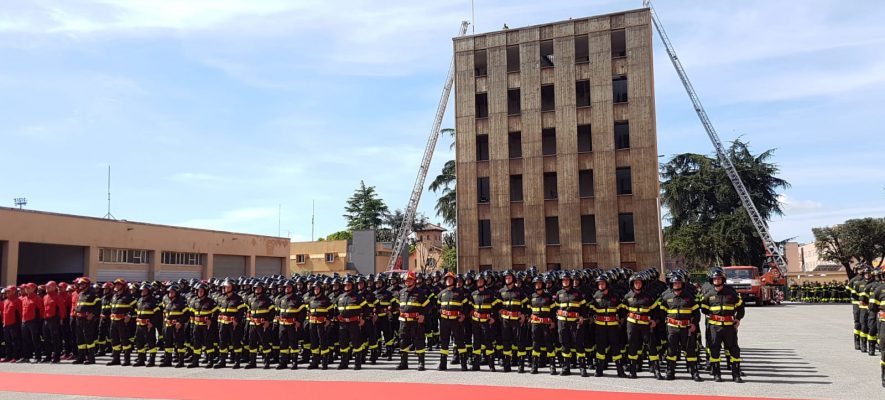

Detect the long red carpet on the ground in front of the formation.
[{"left": 0, "top": 372, "right": 784, "bottom": 400}]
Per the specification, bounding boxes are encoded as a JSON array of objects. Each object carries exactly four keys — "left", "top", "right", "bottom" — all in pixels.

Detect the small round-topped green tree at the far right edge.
[{"left": 811, "top": 218, "right": 885, "bottom": 279}]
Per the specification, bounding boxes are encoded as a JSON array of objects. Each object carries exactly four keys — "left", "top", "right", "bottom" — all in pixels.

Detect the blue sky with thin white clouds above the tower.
[{"left": 0, "top": 0, "right": 885, "bottom": 242}]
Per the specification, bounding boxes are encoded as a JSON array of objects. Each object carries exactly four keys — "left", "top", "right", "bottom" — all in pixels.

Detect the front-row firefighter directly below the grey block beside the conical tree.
[{"left": 335, "top": 276, "right": 372, "bottom": 370}]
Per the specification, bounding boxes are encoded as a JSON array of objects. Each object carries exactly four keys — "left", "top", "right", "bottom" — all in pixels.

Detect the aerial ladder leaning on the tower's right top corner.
[{"left": 642, "top": 0, "right": 787, "bottom": 272}]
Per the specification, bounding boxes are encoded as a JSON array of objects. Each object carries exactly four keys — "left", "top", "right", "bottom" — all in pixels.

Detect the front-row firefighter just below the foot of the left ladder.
[{"left": 396, "top": 272, "right": 432, "bottom": 371}]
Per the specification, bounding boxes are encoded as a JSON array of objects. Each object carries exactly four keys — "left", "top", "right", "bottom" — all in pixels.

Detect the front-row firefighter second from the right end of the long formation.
[{"left": 661, "top": 274, "right": 703, "bottom": 382}]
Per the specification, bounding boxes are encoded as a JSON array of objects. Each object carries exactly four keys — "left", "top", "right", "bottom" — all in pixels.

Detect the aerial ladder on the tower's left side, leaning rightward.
[{"left": 387, "top": 21, "right": 470, "bottom": 271}]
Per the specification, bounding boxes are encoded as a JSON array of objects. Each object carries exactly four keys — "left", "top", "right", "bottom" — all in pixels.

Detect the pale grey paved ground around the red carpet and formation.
[{"left": 0, "top": 304, "right": 885, "bottom": 399}]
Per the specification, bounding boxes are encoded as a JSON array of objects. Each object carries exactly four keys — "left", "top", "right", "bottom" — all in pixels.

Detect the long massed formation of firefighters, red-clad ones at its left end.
[{"left": 0, "top": 268, "right": 748, "bottom": 382}]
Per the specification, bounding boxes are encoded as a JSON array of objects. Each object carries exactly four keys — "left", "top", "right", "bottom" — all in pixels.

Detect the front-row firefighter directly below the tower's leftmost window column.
[{"left": 470, "top": 272, "right": 501, "bottom": 372}]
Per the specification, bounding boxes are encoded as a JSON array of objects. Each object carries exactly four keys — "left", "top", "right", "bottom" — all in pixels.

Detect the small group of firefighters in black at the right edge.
[{"left": 845, "top": 265, "right": 885, "bottom": 387}]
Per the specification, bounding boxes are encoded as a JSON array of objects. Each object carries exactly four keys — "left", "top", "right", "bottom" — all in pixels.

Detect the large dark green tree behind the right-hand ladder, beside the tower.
[{"left": 661, "top": 140, "right": 789, "bottom": 267}]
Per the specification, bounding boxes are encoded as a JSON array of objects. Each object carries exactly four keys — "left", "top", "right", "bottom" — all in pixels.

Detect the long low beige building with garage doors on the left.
[{"left": 0, "top": 207, "right": 289, "bottom": 285}]
